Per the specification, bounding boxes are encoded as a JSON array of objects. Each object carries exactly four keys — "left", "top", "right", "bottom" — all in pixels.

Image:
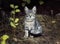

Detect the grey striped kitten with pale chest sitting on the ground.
[{"left": 24, "top": 6, "right": 42, "bottom": 38}]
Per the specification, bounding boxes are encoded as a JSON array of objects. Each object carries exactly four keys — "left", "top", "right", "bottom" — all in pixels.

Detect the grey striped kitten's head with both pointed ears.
[{"left": 25, "top": 6, "right": 36, "bottom": 21}]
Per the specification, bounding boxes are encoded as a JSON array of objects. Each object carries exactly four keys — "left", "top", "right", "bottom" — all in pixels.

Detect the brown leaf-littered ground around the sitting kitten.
[{"left": 0, "top": 15, "right": 60, "bottom": 44}]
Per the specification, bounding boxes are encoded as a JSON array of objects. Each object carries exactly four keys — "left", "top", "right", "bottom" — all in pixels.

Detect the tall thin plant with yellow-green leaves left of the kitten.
[{"left": 10, "top": 4, "right": 20, "bottom": 28}]
